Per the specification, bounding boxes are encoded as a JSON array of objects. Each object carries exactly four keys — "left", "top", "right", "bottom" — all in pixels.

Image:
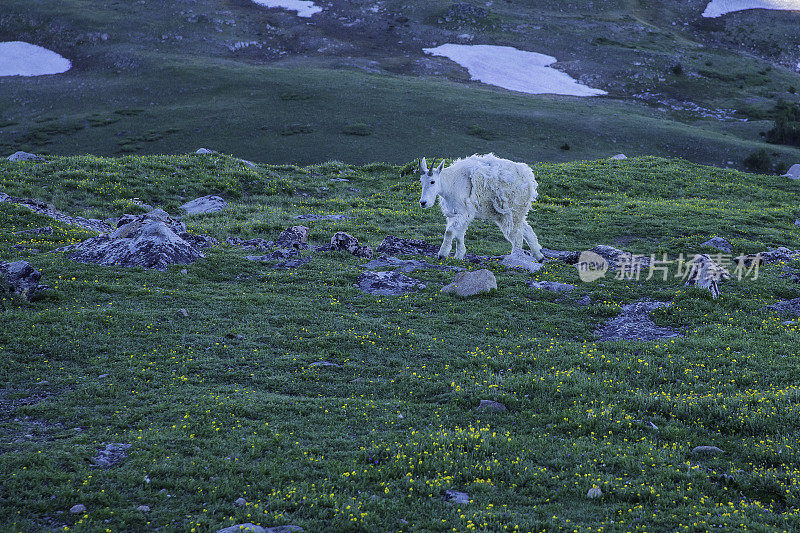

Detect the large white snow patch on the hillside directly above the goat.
[{"left": 423, "top": 44, "right": 607, "bottom": 96}]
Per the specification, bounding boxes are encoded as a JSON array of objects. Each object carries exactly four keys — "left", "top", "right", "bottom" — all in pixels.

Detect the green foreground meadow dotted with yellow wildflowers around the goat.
[{"left": 0, "top": 154, "right": 800, "bottom": 531}]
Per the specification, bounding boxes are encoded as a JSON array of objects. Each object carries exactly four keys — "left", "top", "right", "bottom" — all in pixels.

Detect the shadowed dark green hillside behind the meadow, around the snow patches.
[{"left": 0, "top": 0, "right": 800, "bottom": 166}]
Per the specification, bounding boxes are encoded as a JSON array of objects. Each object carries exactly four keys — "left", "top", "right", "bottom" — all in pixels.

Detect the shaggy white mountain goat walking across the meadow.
[{"left": 419, "top": 154, "right": 544, "bottom": 260}]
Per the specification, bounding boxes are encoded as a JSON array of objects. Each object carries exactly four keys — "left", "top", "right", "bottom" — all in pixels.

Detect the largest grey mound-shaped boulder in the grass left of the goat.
[{"left": 56, "top": 209, "right": 217, "bottom": 270}]
